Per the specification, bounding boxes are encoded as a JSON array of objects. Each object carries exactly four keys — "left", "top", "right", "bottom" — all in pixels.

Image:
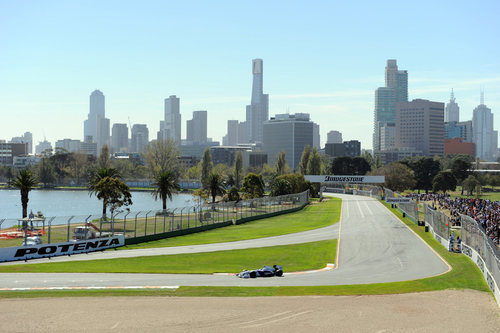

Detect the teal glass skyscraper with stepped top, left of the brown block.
[{"left": 373, "top": 59, "right": 408, "bottom": 154}]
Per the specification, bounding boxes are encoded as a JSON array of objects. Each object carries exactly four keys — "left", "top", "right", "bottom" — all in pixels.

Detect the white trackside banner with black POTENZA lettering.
[{"left": 0, "top": 235, "right": 125, "bottom": 262}]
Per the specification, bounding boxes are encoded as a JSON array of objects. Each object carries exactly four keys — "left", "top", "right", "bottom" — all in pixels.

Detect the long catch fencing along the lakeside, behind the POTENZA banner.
[{"left": 0, "top": 191, "right": 309, "bottom": 247}]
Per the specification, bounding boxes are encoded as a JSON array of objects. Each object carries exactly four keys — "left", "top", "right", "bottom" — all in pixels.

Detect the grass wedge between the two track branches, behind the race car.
[{"left": 0, "top": 239, "right": 337, "bottom": 274}]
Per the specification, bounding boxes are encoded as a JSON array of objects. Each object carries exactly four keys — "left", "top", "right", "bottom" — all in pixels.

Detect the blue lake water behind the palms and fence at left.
[{"left": 0, "top": 190, "right": 197, "bottom": 220}]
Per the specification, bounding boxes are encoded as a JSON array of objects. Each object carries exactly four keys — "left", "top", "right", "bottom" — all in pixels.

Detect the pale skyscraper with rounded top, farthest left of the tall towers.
[{"left": 83, "top": 90, "right": 109, "bottom": 151}]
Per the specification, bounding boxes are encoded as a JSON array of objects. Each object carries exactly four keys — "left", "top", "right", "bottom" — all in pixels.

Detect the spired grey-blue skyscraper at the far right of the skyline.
[{"left": 472, "top": 93, "right": 498, "bottom": 161}]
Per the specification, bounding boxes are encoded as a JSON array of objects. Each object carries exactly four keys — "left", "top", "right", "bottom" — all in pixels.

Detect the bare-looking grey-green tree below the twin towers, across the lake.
[{"left": 144, "top": 139, "right": 180, "bottom": 177}]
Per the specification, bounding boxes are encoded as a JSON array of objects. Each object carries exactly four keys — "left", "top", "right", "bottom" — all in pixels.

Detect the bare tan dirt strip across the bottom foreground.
[{"left": 0, "top": 290, "right": 500, "bottom": 332}]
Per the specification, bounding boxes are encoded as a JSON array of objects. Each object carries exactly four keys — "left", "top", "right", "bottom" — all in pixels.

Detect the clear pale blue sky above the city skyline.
[{"left": 0, "top": 0, "right": 500, "bottom": 149}]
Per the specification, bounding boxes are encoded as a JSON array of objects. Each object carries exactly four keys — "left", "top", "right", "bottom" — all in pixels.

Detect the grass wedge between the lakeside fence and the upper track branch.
[{"left": 120, "top": 198, "right": 342, "bottom": 250}]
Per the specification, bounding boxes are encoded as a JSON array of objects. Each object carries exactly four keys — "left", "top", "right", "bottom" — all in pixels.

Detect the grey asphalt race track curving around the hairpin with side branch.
[{"left": 0, "top": 194, "right": 450, "bottom": 288}]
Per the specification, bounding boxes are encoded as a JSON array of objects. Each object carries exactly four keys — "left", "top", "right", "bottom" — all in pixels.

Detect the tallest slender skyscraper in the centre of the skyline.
[{"left": 246, "top": 59, "right": 269, "bottom": 142}]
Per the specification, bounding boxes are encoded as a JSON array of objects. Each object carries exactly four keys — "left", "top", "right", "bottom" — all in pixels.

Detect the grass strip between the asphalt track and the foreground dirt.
[{"left": 0, "top": 198, "right": 493, "bottom": 298}]
